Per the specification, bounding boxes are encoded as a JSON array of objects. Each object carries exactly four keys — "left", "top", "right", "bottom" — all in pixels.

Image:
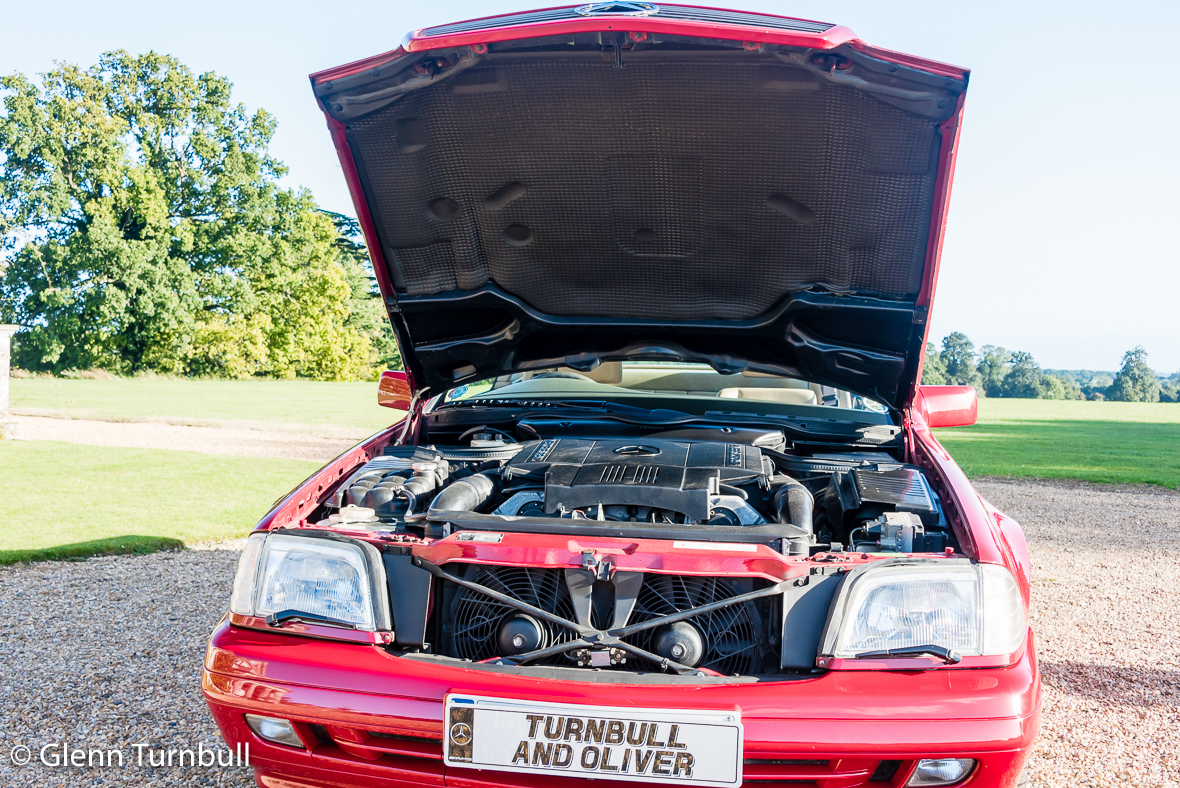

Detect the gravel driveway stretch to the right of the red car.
[{"left": 976, "top": 480, "right": 1180, "bottom": 788}]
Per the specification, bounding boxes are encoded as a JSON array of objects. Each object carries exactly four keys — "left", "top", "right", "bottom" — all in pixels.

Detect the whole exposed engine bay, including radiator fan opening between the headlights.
[{"left": 278, "top": 406, "right": 959, "bottom": 678}]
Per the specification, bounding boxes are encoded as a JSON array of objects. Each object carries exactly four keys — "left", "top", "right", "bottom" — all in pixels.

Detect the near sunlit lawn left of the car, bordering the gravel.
[{"left": 0, "top": 441, "right": 319, "bottom": 564}]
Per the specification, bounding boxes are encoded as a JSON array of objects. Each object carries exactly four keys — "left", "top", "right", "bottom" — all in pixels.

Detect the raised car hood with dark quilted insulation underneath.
[{"left": 312, "top": 2, "right": 968, "bottom": 408}]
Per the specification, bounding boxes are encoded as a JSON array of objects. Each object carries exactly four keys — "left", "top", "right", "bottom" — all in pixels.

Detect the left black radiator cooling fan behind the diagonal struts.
[{"left": 451, "top": 566, "right": 576, "bottom": 664}]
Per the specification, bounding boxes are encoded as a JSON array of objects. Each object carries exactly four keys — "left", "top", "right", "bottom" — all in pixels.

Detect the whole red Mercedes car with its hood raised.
[{"left": 203, "top": 1, "right": 1041, "bottom": 788}]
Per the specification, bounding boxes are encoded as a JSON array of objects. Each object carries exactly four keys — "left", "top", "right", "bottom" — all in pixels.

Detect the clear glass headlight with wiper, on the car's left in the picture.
[{"left": 230, "top": 533, "right": 389, "bottom": 631}]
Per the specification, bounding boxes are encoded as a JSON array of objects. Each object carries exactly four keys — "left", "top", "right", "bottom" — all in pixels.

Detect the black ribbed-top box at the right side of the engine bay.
[{"left": 824, "top": 465, "right": 940, "bottom": 527}]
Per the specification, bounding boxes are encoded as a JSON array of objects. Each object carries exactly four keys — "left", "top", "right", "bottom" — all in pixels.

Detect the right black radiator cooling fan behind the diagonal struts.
[{"left": 627, "top": 574, "right": 761, "bottom": 676}]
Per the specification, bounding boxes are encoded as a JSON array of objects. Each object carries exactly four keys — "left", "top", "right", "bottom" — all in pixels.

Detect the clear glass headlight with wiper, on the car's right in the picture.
[{"left": 821, "top": 559, "right": 1028, "bottom": 658}]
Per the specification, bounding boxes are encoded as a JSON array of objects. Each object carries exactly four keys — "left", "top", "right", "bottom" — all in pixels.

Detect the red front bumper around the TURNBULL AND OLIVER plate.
[{"left": 202, "top": 622, "right": 1041, "bottom": 788}]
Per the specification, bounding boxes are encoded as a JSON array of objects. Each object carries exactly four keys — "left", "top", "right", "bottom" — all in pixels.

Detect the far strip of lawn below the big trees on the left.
[{"left": 9, "top": 377, "right": 401, "bottom": 434}]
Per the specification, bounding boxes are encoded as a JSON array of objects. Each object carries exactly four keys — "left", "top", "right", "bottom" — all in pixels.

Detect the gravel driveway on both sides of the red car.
[{"left": 0, "top": 480, "right": 1180, "bottom": 788}]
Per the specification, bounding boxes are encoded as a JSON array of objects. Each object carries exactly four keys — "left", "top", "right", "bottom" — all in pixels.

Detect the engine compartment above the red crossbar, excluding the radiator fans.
[{"left": 322, "top": 433, "right": 958, "bottom": 556}]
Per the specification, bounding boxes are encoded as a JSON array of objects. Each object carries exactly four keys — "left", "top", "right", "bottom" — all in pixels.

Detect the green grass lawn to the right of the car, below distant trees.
[{"left": 936, "top": 399, "right": 1180, "bottom": 488}]
